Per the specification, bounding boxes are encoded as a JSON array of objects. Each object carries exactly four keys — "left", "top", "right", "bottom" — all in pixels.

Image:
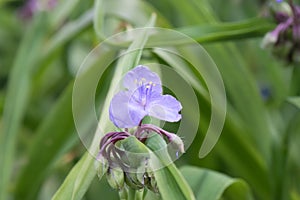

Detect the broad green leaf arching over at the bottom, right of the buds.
[{"left": 180, "top": 166, "right": 253, "bottom": 200}]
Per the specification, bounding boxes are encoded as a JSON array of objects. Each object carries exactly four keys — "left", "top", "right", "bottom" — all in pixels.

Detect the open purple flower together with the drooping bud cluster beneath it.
[{"left": 96, "top": 66, "right": 184, "bottom": 195}]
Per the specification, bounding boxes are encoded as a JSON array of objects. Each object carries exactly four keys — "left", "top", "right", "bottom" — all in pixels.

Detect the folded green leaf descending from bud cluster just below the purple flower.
[{"left": 146, "top": 134, "right": 195, "bottom": 200}]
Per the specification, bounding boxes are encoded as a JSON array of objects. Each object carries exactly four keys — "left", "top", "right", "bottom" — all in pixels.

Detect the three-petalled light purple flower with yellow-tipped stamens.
[{"left": 109, "top": 65, "right": 182, "bottom": 128}]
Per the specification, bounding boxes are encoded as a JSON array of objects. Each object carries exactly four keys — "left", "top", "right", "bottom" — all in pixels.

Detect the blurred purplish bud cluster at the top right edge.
[{"left": 262, "top": 0, "right": 300, "bottom": 63}]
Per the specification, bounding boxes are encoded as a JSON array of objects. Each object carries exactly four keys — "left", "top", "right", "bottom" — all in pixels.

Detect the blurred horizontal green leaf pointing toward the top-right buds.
[{"left": 148, "top": 18, "right": 274, "bottom": 45}]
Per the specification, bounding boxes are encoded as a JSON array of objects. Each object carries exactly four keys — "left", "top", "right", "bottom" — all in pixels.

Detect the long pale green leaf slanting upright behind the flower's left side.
[{"left": 53, "top": 14, "right": 155, "bottom": 199}]
